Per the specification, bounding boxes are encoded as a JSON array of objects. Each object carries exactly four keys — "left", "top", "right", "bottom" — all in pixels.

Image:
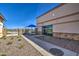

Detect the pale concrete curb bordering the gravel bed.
[{"left": 21, "top": 35, "right": 54, "bottom": 56}]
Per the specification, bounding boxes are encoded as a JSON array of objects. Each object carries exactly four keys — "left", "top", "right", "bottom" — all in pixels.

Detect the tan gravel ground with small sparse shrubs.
[{"left": 0, "top": 36, "right": 42, "bottom": 56}]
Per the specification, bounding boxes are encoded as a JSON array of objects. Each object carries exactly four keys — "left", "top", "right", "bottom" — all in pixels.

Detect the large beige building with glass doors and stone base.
[{"left": 37, "top": 3, "right": 79, "bottom": 40}]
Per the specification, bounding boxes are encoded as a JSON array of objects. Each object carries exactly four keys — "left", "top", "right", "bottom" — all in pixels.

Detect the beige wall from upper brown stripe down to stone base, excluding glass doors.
[{"left": 38, "top": 14, "right": 79, "bottom": 33}]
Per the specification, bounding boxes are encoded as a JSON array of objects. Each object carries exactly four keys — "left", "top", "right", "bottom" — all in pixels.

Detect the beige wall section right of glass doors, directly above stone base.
[{"left": 53, "top": 22, "right": 79, "bottom": 33}]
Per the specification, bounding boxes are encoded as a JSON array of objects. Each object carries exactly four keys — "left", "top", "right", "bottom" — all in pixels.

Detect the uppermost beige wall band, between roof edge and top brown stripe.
[{"left": 37, "top": 3, "right": 79, "bottom": 23}]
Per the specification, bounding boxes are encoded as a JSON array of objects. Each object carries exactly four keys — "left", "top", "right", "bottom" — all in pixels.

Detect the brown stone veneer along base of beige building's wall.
[{"left": 53, "top": 32, "right": 79, "bottom": 40}]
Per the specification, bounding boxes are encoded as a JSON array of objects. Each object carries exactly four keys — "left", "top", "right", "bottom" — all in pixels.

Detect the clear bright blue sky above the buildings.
[{"left": 0, "top": 3, "right": 59, "bottom": 29}]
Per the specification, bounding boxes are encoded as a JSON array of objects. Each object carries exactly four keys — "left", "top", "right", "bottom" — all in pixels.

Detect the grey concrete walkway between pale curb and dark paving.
[{"left": 25, "top": 35, "right": 77, "bottom": 56}]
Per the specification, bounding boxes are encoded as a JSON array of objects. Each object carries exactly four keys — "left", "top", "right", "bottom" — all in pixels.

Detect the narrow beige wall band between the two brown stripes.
[{"left": 38, "top": 14, "right": 79, "bottom": 26}]
